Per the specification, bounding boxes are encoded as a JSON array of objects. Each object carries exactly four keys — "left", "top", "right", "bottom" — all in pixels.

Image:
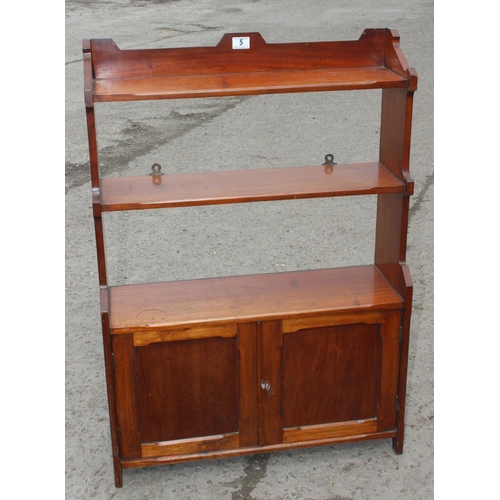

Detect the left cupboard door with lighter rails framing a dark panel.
[{"left": 113, "top": 324, "right": 258, "bottom": 458}]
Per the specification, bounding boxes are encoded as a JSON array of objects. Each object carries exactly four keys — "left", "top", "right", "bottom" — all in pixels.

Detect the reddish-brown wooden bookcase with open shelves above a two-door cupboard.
[{"left": 83, "top": 29, "right": 417, "bottom": 487}]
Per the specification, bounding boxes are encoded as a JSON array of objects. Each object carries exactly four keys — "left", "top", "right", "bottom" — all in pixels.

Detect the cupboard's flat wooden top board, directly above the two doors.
[{"left": 109, "top": 265, "right": 404, "bottom": 334}]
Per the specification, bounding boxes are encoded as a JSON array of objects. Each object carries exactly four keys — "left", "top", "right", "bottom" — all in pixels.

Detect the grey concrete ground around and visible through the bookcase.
[{"left": 65, "top": 0, "right": 434, "bottom": 500}]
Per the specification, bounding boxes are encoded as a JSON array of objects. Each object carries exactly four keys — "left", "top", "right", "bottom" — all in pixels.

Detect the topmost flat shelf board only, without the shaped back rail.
[{"left": 93, "top": 66, "right": 408, "bottom": 102}]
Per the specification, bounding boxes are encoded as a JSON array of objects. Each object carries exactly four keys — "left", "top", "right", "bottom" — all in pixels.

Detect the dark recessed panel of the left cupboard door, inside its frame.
[{"left": 136, "top": 337, "right": 239, "bottom": 443}]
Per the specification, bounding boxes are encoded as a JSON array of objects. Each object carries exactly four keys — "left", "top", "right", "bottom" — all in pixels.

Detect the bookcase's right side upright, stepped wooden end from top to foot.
[{"left": 374, "top": 30, "right": 417, "bottom": 453}]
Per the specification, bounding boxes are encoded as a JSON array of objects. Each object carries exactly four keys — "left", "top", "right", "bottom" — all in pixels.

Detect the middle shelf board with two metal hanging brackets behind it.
[{"left": 101, "top": 162, "right": 404, "bottom": 211}]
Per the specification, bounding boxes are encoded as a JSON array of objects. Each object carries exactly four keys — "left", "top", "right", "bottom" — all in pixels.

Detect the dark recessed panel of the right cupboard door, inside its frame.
[{"left": 283, "top": 324, "right": 380, "bottom": 428}]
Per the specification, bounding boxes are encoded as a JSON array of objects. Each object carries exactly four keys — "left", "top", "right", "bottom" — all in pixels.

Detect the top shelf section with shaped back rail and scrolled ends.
[{"left": 83, "top": 29, "right": 417, "bottom": 102}]
